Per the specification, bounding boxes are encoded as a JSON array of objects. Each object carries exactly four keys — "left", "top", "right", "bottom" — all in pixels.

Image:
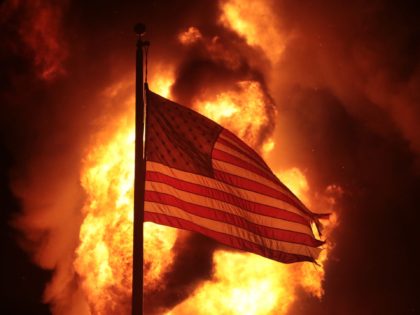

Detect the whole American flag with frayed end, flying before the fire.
[{"left": 144, "top": 91, "right": 325, "bottom": 263}]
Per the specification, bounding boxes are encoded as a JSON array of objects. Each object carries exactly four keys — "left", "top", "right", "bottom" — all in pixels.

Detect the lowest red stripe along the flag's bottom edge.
[{"left": 144, "top": 209, "right": 315, "bottom": 263}]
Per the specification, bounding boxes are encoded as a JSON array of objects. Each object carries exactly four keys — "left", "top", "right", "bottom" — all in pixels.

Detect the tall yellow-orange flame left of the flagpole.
[{"left": 75, "top": 126, "right": 134, "bottom": 314}]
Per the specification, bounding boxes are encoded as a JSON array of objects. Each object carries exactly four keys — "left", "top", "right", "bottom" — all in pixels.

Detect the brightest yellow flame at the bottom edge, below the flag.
[{"left": 170, "top": 250, "right": 295, "bottom": 315}]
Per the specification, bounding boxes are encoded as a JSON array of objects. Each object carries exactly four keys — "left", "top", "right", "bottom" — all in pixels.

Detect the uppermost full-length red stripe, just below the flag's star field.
[{"left": 146, "top": 171, "right": 310, "bottom": 226}]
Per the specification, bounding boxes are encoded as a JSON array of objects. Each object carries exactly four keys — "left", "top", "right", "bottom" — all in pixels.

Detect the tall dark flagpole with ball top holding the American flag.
[{"left": 131, "top": 23, "right": 149, "bottom": 315}]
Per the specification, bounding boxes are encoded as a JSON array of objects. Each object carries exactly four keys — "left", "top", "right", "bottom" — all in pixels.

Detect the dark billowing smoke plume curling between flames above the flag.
[{"left": 172, "top": 30, "right": 275, "bottom": 149}]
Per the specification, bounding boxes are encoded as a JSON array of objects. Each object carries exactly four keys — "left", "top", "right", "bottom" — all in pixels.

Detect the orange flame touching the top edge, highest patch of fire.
[{"left": 220, "top": 0, "right": 285, "bottom": 63}]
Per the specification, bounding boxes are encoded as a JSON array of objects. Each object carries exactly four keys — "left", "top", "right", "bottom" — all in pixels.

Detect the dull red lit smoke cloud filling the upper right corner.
[{"left": 270, "top": 1, "right": 420, "bottom": 163}]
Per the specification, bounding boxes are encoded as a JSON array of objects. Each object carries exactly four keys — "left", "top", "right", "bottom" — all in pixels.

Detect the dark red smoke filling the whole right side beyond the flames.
[{"left": 266, "top": 1, "right": 420, "bottom": 314}]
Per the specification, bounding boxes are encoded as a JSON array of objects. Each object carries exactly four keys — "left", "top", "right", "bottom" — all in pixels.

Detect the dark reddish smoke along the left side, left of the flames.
[{"left": 0, "top": 1, "right": 141, "bottom": 314}]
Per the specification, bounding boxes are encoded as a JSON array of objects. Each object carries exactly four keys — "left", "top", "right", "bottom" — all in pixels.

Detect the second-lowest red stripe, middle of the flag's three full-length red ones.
[{"left": 145, "top": 191, "right": 324, "bottom": 247}]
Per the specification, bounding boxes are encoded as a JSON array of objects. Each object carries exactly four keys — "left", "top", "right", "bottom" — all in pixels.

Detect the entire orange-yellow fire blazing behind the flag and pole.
[{"left": 74, "top": 0, "right": 339, "bottom": 315}]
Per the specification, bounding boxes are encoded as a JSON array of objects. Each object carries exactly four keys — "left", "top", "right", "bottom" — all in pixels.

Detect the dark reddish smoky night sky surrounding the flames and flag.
[{"left": 0, "top": 0, "right": 420, "bottom": 315}]
